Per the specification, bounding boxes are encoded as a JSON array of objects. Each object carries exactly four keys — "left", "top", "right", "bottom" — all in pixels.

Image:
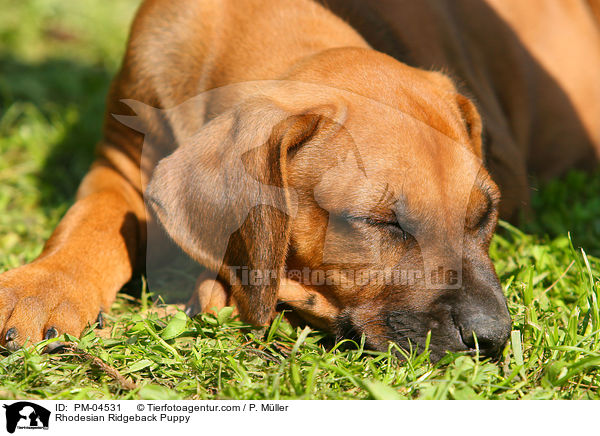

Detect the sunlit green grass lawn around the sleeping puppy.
[{"left": 0, "top": 0, "right": 600, "bottom": 399}]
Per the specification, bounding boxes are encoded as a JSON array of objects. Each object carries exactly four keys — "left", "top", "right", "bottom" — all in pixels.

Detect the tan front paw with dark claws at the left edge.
[{"left": 0, "top": 263, "right": 101, "bottom": 351}]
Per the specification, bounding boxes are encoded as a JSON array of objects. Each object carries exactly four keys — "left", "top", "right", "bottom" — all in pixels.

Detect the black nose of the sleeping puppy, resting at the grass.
[{"left": 458, "top": 312, "right": 511, "bottom": 357}]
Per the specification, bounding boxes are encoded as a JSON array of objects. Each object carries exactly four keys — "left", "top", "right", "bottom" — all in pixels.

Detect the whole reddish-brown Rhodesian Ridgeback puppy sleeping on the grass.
[{"left": 0, "top": 0, "right": 600, "bottom": 359}]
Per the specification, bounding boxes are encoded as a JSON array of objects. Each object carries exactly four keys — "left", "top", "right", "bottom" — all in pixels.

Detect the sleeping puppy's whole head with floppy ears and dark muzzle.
[{"left": 147, "top": 49, "right": 510, "bottom": 358}]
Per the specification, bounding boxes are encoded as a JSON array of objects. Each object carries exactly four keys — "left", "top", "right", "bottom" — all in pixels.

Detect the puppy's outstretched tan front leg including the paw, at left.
[{"left": 0, "top": 147, "right": 145, "bottom": 350}]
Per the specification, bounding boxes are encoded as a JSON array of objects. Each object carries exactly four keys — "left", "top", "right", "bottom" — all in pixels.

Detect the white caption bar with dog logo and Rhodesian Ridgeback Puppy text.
[{"left": 0, "top": 400, "right": 600, "bottom": 436}]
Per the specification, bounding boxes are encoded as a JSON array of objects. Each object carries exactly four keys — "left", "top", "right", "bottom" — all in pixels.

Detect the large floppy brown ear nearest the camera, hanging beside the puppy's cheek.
[{"left": 146, "top": 99, "right": 328, "bottom": 324}]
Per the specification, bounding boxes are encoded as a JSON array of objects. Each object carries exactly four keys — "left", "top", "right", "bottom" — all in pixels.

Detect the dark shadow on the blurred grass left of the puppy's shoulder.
[{"left": 0, "top": 55, "right": 113, "bottom": 211}]
